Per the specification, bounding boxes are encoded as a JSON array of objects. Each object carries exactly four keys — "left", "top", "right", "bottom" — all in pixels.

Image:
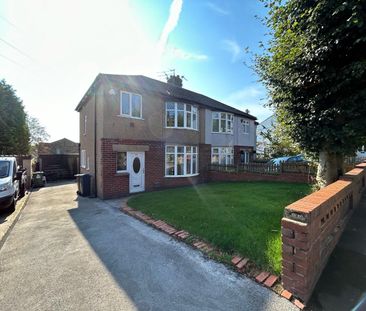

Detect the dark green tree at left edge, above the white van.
[{"left": 0, "top": 80, "right": 29, "bottom": 155}]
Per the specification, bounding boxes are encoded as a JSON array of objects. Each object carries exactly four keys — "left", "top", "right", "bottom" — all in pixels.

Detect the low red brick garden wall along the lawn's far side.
[{"left": 208, "top": 171, "right": 312, "bottom": 183}]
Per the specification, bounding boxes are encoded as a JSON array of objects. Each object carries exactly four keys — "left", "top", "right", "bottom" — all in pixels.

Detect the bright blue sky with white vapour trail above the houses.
[{"left": 0, "top": 0, "right": 271, "bottom": 141}]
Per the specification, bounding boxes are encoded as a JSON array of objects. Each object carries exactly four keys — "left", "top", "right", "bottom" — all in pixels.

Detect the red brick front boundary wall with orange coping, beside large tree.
[{"left": 281, "top": 163, "right": 366, "bottom": 302}]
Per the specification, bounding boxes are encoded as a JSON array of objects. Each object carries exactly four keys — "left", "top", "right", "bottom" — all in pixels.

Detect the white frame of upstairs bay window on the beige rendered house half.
[{"left": 165, "top": 101, "right": 199, "bottom": 131}]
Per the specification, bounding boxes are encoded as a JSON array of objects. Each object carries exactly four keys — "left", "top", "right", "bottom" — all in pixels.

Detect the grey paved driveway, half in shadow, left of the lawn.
[{"left": 0, "top": 183, "right": 296, "bottom": 311}]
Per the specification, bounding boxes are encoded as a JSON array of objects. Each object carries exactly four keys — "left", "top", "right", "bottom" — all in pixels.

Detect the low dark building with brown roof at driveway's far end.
[{"left": 36, "top": 138, "right": 79, "bottom": 180}]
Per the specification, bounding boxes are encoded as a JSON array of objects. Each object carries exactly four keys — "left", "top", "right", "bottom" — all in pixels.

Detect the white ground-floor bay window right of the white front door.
[{"left": 165, "top": 145, "right": 198, "bottom": 177}]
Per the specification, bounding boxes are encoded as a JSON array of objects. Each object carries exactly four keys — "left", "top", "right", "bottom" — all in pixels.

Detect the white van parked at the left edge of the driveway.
[{"left": 0, "top": 157, "right": 20, "bottom": 210}]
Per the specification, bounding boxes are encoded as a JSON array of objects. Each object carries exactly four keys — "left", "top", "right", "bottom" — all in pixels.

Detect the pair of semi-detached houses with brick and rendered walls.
[{"left": 76, "top": 74, "right": 256, "bottom": 199}]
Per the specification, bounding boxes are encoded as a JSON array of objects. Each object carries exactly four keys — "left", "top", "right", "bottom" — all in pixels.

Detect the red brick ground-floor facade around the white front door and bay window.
[{"left": 98, "top": 138, "right": 211, "bottom": 199}]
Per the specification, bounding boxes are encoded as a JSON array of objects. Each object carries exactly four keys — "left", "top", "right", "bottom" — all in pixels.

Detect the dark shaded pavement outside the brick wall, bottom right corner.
[{"left": 308, "top": 195, "right": 366, "bottom": 311}]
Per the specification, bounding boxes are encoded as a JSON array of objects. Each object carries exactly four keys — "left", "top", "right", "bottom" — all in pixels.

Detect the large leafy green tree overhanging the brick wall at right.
[{"left": 256, "top": 0, "right": 366, "bottom": 186}]
